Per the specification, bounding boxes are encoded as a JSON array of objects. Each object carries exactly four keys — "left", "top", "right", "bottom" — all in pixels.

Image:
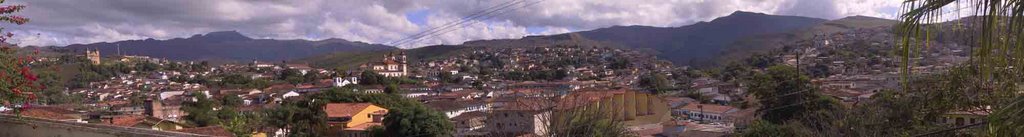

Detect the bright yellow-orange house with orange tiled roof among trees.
[{"left": 324, "top": 103, "right": 388, "bottom": 137}]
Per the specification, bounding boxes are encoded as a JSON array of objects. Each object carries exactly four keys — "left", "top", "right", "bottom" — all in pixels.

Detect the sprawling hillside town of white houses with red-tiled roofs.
[{"left": 0, "top": 25, "right": 983, "bottom": 136}]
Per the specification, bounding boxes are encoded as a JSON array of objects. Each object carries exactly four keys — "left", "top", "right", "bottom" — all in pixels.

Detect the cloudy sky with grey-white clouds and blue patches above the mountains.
[{"left": 0, "top": 0, "right": 901, "bottom": 48}]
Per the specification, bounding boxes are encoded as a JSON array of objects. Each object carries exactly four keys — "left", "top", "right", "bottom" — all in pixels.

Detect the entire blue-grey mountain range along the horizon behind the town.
[{"left": 61, "top": 11, "right": 896, "bottom": 67}]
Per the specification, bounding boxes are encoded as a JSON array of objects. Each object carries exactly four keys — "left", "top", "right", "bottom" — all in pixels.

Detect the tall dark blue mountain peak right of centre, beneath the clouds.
[{"left": 579, "top": 11, "right": 826, "bottom": 65}]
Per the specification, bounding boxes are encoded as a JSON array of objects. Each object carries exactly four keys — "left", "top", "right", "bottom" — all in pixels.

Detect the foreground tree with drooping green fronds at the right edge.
[{"left": 896, "top": 0, "right": 1024, "bottom": 136}]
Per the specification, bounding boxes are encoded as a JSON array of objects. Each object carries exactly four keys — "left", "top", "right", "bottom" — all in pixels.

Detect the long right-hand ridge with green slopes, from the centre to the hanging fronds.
[{"left": 304, "top": 11, "right": 895, "bottom": 67}]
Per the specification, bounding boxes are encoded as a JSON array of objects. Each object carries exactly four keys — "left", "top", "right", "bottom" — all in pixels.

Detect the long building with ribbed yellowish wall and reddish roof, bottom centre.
[{"left": 485, "top": 90, "right": 671, "bottom": 136}]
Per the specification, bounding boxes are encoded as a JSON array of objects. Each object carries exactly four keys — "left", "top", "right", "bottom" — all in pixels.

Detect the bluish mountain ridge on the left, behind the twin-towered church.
[{"left": 67, "top": 31, "right": 396, "bottom": 61}]
